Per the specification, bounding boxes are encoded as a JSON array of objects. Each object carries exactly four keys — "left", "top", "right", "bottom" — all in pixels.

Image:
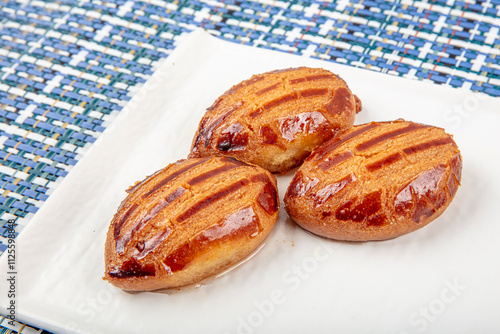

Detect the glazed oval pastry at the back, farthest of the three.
[{"left": 189, "top": 67, "right": 361, "bottom": 173}]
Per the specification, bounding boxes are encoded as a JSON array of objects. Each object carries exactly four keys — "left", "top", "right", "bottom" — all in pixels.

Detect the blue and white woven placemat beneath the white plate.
[{"left": 0, "top": 0, "right": 500, "bottom": 333}]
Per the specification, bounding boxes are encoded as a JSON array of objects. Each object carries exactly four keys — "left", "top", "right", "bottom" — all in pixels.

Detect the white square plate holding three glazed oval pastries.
[{"left": 0, "top": 31, "right": 500, "bottom": 334}]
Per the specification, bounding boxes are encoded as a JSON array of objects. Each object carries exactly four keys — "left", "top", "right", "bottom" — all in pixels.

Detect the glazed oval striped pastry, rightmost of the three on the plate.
[{"left": 284, "top": 120, "right": 462, "bottom": 241}]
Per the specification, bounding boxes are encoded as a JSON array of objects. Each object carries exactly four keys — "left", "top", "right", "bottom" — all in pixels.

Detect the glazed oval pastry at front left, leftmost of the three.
[{"left": 104, "top": 157, "right": 279, "bottom": 291}]
